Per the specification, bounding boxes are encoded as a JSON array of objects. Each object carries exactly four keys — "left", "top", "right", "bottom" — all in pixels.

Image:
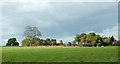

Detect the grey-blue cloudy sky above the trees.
[{"left": 0, "top": 0, "right": 118, "bottom": 46}]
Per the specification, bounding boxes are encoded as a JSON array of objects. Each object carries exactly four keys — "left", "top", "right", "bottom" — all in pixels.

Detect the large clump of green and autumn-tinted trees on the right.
[{"left": 74, "top": 33, "right": 115, "bottom": 46}]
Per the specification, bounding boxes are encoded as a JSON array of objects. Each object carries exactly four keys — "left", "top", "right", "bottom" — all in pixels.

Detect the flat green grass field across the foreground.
[{"left": 2, "top": 47, "right": 118, "bottom": 62}]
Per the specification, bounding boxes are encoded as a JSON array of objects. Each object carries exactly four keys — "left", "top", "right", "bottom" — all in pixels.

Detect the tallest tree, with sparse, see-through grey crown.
[{"left": 24, "top": 26, "right": 42, "bottom": 46}]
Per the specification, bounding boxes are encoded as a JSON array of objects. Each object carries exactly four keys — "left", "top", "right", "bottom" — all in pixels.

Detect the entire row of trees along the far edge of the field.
[{"left": 6, "top": 26, "right": 119, "bottom": 46}]
